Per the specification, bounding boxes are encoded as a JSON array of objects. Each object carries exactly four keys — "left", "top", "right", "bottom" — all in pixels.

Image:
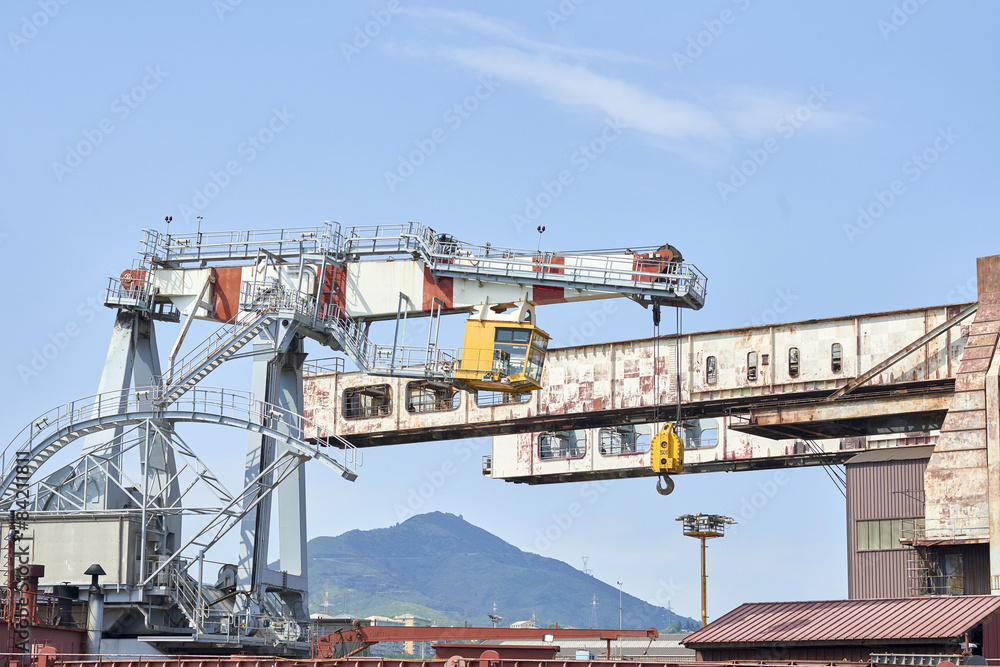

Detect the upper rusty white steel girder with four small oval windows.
[{"left": 305, "top": 306, "right": 968, "bottom": 446}]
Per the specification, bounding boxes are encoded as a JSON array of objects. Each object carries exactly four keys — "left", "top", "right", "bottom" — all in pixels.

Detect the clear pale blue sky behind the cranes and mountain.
[{"left": 0, "top": 0, "right": 1000, "bottom": 616}]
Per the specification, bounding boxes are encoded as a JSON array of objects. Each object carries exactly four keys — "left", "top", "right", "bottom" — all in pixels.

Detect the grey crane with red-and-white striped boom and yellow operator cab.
[{"left": 0, "top": 223, "right": 706, "bottom": 655}]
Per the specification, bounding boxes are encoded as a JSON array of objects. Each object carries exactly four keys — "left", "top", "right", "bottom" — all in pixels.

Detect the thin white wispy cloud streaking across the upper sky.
[{"left": 394, "top": 8, "right": 858, "bottom": 164}]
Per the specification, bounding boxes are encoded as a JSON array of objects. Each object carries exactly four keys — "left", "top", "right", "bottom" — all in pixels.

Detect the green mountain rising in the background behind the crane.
[{"left": 308, "top": 512, "right": 697, "bottom": 629}]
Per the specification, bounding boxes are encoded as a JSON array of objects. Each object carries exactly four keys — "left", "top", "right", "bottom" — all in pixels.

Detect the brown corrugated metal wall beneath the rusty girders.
[{"left": 847, "top": 459, "right": 927, "bottom": 600}]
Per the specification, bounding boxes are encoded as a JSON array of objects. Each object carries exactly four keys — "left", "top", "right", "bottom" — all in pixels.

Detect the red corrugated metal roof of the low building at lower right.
[{"left": 683, "top": 595, "right": 1000, "bottom": 646}]
